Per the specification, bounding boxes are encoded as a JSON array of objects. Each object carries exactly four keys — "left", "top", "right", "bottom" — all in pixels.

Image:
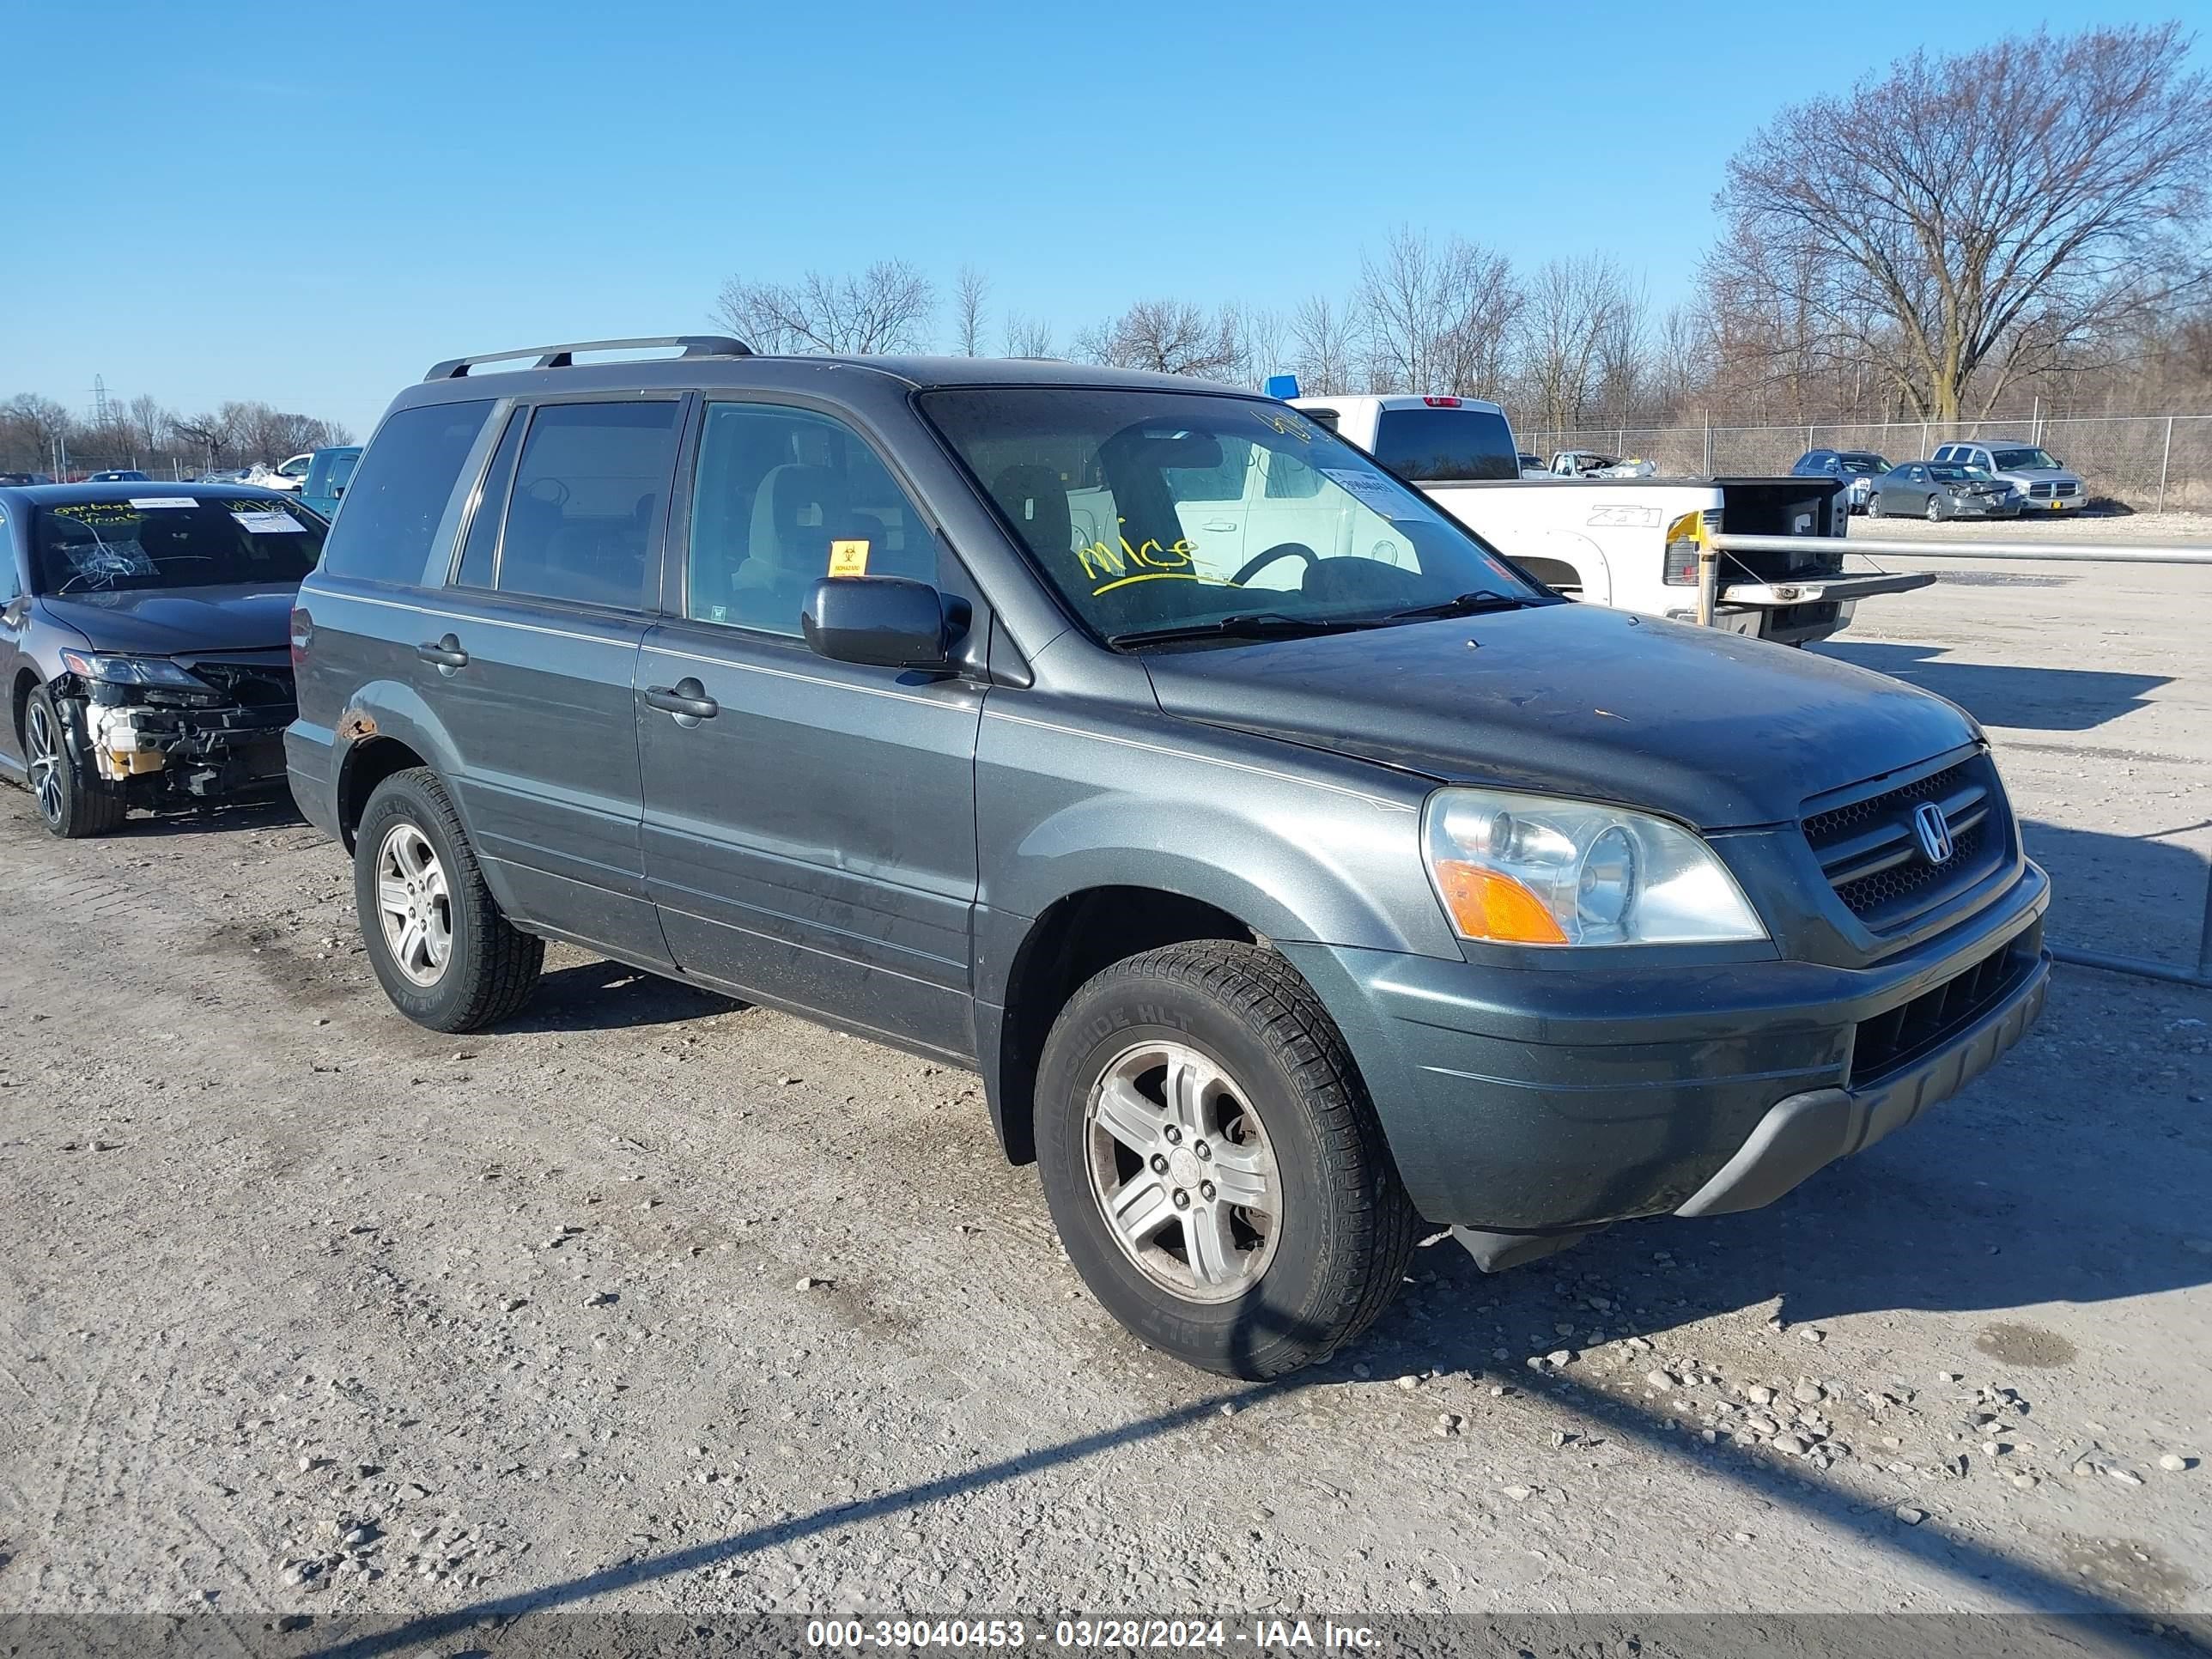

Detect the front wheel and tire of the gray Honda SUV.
[{"left": 1037, "top": 940, "right": 1418, "bottom": 1380}]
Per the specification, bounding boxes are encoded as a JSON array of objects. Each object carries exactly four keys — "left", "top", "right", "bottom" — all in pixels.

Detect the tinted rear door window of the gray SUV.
[{"left": 495, "top": 400, "right": 684, "bottom": 611}]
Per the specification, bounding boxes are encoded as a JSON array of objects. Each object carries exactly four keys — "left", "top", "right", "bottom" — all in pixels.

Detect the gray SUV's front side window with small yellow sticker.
[{"left": 684, "top": 403, "right": 938, "bottom": 635}]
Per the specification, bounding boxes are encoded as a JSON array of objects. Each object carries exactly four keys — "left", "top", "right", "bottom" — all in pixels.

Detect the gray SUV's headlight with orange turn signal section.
[{"left": 1422, "top": 790, "right": 1767, "bottom": 945}]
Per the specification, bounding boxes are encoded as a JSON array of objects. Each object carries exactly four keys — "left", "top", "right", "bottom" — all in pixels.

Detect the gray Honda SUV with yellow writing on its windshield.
[{"left": 288, "top": 337, "right": 2048, "bottom": 1376}]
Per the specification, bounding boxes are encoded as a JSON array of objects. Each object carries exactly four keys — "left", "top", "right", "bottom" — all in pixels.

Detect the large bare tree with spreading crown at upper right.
[{"left": 1714, "top": 24, "right": 2212, "bottom": 420}]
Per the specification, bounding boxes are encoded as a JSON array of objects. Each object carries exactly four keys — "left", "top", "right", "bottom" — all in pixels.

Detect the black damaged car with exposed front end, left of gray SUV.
[{"left": 0, "top": 484, "right": 323, "bottom": 836}]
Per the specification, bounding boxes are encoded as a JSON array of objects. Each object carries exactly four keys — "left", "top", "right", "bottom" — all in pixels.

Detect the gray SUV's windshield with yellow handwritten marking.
[{"left": 921, "top": 387, "right": 1544, "bottom": 641}]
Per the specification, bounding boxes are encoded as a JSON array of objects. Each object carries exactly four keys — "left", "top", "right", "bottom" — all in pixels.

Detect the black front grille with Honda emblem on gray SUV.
[{"left": 1802, "top": 754, "right": 2008, "bottom": 933}]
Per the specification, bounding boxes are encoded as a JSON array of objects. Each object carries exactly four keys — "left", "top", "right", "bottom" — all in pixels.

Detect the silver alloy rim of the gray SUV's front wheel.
[{"left": 1084, "top": 1040, "right": 1283, "bottom": 1303}]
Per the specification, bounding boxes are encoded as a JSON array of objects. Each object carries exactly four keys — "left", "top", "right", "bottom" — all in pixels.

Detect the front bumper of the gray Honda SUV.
[{"left": 1279, "top": 865, "right": 2051, "bottom": 1234}]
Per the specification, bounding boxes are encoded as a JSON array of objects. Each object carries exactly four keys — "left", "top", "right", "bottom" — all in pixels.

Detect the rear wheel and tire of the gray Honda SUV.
[{"left": 354, "top": 768, "right": 546, "bottom": 1030}]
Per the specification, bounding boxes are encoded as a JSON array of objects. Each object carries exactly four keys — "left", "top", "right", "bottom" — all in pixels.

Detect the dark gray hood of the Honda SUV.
[{"left": 1144, "top": 604, "right": 1980, "bottom": 830}]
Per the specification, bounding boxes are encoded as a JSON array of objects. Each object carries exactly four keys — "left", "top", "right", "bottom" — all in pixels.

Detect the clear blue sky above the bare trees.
[{"left": 0, "top": 0, "right": 2212, "bottom": 434}]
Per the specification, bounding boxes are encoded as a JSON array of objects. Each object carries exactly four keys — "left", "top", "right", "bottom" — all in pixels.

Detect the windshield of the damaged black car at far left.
[{"left": 31, "top": 495, "right": 323, "bottom": 598}]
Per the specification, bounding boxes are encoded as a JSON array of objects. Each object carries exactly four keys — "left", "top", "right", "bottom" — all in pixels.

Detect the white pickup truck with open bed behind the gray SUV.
[{"left": 1291, "top": 396, "right": 1936, "bottom": 646}]
